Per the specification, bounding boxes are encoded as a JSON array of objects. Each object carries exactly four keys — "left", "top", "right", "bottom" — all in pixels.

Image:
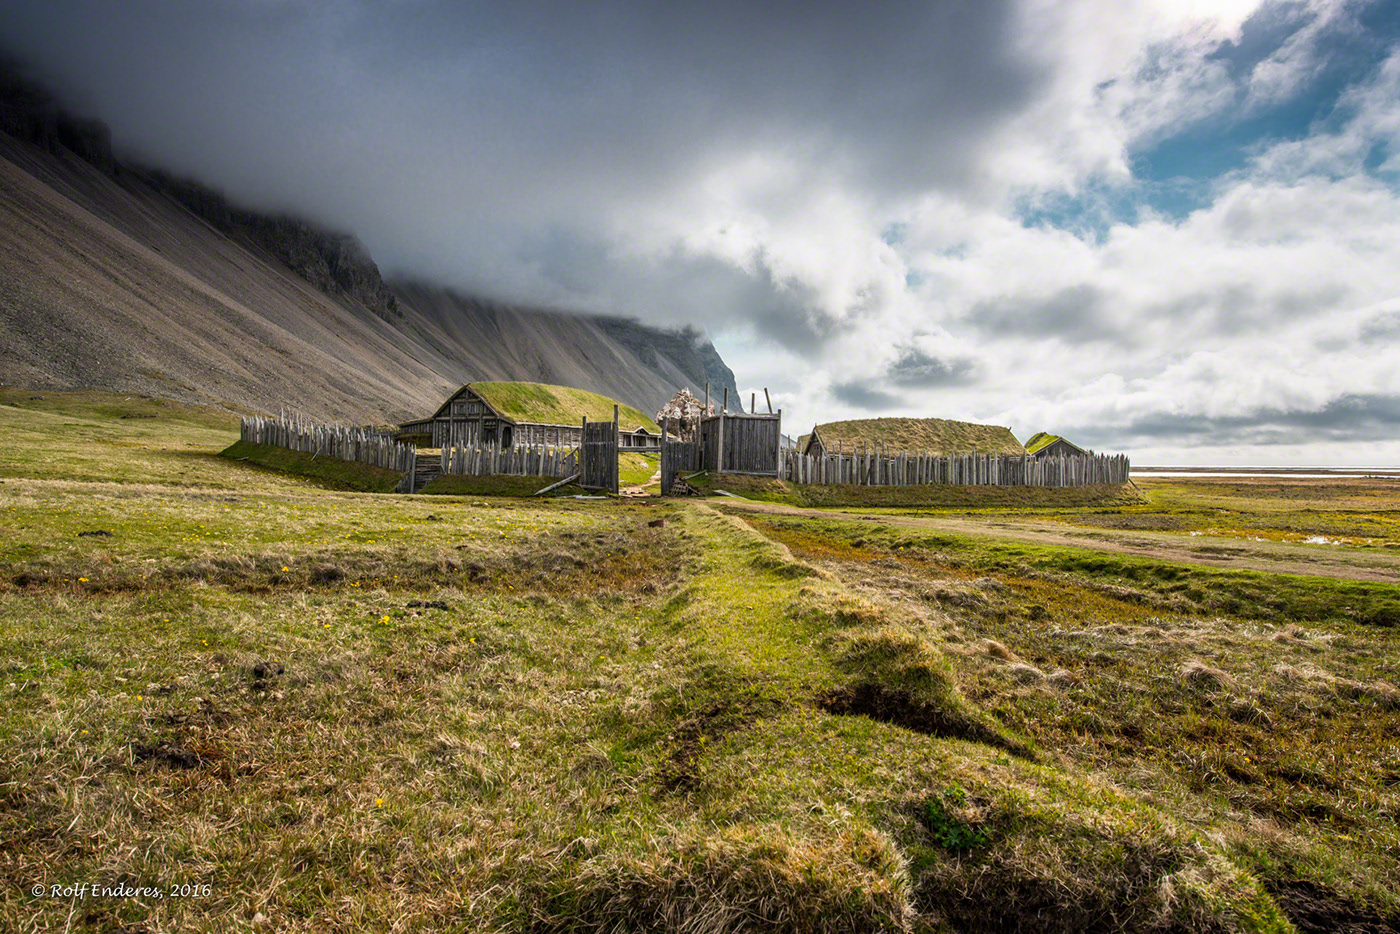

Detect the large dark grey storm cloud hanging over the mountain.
[{"left": 0, "top": 0, "right": 1039, "bottom": 322}]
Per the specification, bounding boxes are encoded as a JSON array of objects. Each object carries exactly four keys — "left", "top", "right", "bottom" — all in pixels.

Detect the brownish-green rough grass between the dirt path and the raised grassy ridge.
[{"left": 733, "top": 518, "right": 1400, "bottom": 930}]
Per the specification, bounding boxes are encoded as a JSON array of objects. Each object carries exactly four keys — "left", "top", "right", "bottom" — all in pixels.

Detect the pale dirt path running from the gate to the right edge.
[{"left": 713, "top": 499, "right": 1400, "bottom": 584}]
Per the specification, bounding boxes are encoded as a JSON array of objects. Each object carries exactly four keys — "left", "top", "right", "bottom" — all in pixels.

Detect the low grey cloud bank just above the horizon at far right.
[{"left": 1065, "top": 393, "right": 1400, "bottom": 449}]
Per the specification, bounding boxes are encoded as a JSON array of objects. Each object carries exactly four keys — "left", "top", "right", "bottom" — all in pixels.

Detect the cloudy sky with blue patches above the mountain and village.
[{"left": 0, "top": 0, "right": 1400, "bottom": 466}]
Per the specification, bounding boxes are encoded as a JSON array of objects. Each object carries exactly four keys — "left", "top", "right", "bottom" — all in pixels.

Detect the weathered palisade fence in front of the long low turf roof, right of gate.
[{"left": 778, "top": 451, "right": 1128, "bottom": 486}]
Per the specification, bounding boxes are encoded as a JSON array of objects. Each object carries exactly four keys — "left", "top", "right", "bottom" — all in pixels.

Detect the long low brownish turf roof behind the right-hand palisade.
[{"left": 797, "top": 417, "right": 1026, "bottom": 456}]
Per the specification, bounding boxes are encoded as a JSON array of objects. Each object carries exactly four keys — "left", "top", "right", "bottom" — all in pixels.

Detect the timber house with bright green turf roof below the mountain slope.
[{"left": 399, "top": 382, "right": 661, "bottom": 451}]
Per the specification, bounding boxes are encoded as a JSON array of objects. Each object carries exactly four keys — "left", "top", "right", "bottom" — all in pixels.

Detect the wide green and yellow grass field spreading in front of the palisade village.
[{"left": 0, "top": 393, "right": 1400, "bottom": 931}]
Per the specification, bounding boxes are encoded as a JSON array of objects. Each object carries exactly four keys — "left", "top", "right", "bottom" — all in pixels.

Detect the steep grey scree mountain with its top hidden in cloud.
[{"left": 0, "top": 73, "right": 738, "bottom": 423}]
